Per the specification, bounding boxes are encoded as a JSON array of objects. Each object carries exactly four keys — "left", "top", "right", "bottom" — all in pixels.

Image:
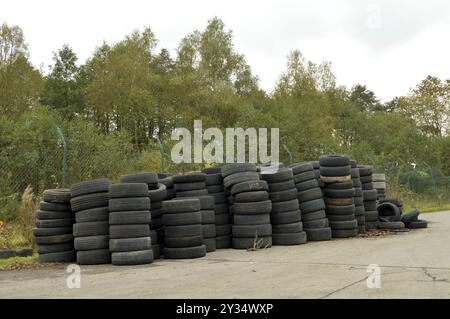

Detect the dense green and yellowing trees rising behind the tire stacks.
[{"left": 0, "top": 18, "right": 450, "bottom": 204}]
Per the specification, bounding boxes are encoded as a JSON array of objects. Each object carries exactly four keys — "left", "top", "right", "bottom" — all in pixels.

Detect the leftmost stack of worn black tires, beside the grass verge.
[{"left": 34, "top": 189, "right": 76, "bottom": 262}]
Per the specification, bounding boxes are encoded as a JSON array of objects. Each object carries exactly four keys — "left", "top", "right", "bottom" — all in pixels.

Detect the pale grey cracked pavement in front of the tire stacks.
[{"left": 0, "top": 211, "right": 450, "bottom": 298}]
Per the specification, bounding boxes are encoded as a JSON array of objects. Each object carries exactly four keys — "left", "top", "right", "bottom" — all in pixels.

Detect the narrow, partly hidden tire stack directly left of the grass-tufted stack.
[{"left": 202, "top": 167, "right": 231, "bottom": 249}]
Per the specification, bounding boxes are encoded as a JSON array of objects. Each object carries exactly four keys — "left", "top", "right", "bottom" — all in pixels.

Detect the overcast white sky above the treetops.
[{"left": 0, "top": 0, "right": 450, "bottom": 100}]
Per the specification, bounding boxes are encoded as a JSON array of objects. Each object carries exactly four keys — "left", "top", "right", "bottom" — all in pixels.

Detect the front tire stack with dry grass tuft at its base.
[{"left": 231, "top": 180, "right": 272, "bottom": 249}]
